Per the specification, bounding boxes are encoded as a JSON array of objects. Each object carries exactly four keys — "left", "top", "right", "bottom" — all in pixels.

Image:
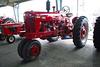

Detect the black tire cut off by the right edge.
[{"left": 93, "top": 17, "right": 100, "bottom": 50}]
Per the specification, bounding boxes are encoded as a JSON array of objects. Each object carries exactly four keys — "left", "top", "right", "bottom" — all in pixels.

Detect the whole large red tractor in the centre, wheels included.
[{"left": 18, "top": 0, "right": 88, "bottom": 61}]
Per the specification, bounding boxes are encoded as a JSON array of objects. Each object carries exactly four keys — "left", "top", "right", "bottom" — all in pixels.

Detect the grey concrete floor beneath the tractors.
[{"left": 0, "top": 39, "right": 100, "bottom": 67}]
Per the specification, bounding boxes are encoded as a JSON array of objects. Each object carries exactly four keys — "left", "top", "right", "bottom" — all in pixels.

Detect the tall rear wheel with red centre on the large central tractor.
[{"left": 73, "top": 16, "right": 88, "bottom": 48}]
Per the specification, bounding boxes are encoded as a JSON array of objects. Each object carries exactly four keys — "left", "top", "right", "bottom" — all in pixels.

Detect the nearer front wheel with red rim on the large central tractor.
[{"left": 22, "top": 40, "right": 41, "bottom": 61}]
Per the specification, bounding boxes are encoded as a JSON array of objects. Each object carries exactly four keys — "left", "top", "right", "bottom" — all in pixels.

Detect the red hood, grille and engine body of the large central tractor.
[{"left": 21, "top": 11, "right": 73, "bottom": 39}]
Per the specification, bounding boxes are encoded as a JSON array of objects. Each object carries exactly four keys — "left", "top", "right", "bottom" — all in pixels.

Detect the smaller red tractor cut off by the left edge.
[{"left": 0, "top": 17, "right": 23, "bottom": 44}]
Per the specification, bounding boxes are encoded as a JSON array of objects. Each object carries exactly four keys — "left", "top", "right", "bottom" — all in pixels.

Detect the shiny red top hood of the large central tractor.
[{"left": 24, "top": 11, "right": 60, "bottom": 21}]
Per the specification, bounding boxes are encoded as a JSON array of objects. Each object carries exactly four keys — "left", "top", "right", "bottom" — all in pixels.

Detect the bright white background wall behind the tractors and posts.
[{"left": 0, "top": 0, "right": 100, "bottom": 23}]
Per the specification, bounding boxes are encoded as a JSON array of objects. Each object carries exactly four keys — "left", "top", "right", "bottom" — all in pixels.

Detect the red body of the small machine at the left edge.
[{"left": 0, "top": 23, "right": 23, "bottom": 36}]
